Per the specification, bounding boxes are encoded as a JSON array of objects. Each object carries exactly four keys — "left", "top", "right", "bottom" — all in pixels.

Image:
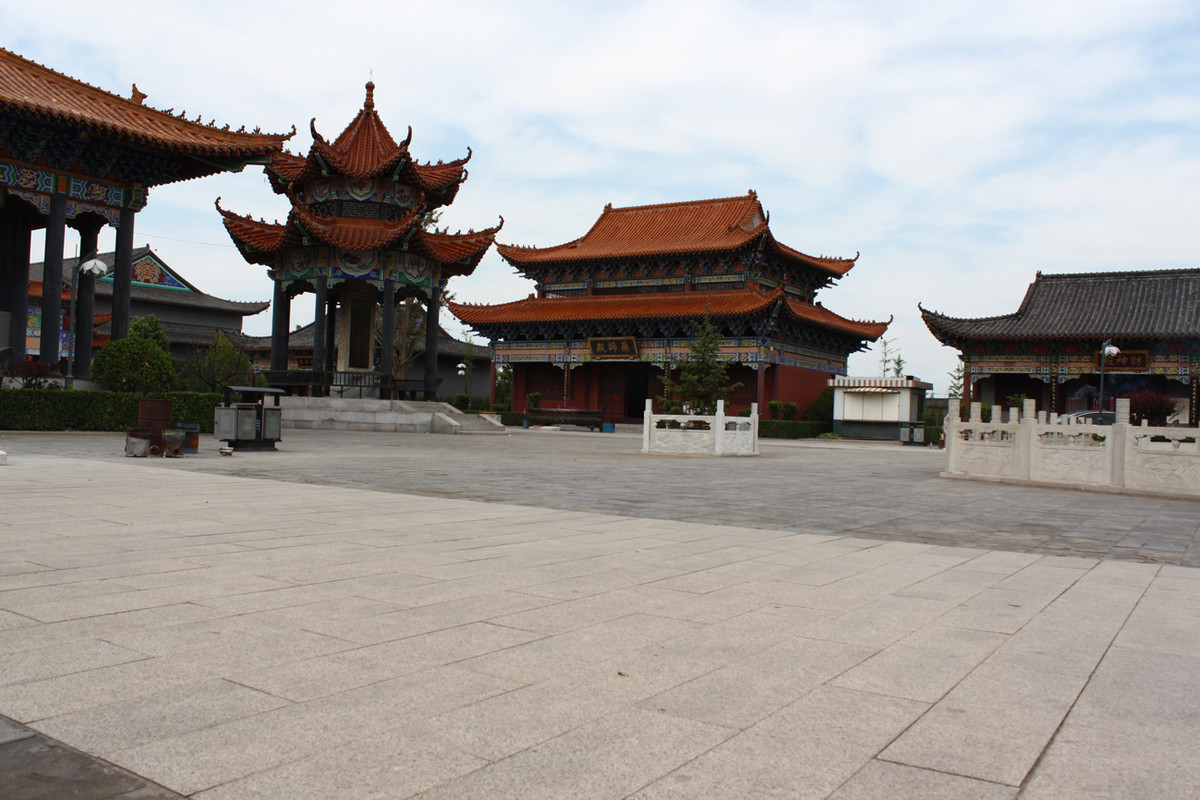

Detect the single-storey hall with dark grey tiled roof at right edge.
[{"left": 918, "top": 270, "right": 1200, "bottom": 425}]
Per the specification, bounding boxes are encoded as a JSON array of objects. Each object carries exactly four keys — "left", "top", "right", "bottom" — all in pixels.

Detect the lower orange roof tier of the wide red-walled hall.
[{"left": 448, "top": 289, "right": 889, "bottom": 341}]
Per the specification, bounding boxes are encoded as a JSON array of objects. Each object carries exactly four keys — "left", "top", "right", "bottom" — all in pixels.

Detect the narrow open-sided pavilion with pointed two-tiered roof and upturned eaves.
[{"left": 217, "top": 83, "right": 503, "bottom": 399}]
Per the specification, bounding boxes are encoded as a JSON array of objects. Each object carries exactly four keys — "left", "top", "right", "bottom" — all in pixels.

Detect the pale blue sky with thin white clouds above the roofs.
[{"left": 0, "top": 0, "right": 1200, "bottom": 395}]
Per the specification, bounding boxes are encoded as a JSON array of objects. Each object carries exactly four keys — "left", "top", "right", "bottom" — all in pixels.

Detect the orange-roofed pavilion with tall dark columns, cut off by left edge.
[{"left": 0, "top": 48, "right": 292, "bottom": 378}]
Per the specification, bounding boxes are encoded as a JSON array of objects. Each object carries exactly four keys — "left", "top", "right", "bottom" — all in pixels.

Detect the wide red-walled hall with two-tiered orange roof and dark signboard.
[{"left": 450, "top": 192, "right": 889, "bottom": 419}]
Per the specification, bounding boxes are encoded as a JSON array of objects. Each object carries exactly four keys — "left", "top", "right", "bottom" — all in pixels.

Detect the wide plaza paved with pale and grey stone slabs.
[{"left": 0, "top": 431, "right": 1200, "bottom": 800}]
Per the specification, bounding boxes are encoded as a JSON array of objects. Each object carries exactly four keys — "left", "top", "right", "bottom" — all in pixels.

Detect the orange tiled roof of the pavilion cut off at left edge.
[{"left": 0, "top": 48, "right": 295, "bottom": 159}]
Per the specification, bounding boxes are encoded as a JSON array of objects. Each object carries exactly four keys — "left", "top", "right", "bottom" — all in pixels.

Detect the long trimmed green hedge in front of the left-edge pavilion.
[{"left": 0, "top": 389, "right": 221, "bottom": 433}]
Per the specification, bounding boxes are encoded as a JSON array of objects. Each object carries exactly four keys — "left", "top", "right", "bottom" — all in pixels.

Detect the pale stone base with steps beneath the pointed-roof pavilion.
[{"left": 280, "top": 397, "right": 505, "bottom": 434}]
